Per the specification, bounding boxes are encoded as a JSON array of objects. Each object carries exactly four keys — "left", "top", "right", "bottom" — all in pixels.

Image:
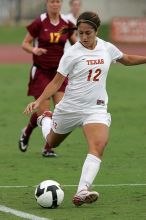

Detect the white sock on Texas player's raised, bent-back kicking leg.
[{"left": 42, "top": 117, "right": 52, "bottom": 140}]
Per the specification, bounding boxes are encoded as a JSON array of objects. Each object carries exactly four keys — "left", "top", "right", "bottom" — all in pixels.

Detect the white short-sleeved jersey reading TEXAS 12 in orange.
[{"left": 57, "top": 38, "right": 123, "bottom": 112}]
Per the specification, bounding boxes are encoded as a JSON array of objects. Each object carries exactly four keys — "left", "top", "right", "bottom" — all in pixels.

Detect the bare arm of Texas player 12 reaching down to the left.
[{"left": 24, "top": 73, "right": 65, "bottom": 114}]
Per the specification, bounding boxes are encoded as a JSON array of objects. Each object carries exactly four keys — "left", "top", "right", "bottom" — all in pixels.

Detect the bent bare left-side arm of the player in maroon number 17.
[{"left": 22, "top": 33, "right": 47, "bottom": 56}]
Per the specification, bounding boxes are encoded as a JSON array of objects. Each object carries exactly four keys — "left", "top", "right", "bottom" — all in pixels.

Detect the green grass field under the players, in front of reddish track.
[{"left": 0, "top": 62, "right": 146, "bottom": 220}]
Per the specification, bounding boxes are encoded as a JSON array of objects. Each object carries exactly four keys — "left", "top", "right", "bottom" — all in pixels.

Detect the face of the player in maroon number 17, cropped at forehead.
[{"left": 47, "top": 0, "right": 62, "bottom": 14}]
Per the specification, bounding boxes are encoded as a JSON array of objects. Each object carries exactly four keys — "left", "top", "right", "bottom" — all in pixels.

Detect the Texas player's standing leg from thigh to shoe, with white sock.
[{"left": 73, "top": 111, "right": 109, "bottom": 206}]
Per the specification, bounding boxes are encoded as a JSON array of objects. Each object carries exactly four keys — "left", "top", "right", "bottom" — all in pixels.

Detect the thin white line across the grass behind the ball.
[{"left": 0, "top": 183, "right": 146, "bottom": 188}]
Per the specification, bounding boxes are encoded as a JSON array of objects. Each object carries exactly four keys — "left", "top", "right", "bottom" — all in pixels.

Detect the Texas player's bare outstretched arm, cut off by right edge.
[{"left": 117, "top": 54, "right": 146, "bottom": 66}]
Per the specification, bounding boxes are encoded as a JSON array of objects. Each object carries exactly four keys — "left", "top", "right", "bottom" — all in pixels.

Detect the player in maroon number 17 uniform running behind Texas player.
[{"left": 19, "top": 0, "right": 76, "bottom": 157}]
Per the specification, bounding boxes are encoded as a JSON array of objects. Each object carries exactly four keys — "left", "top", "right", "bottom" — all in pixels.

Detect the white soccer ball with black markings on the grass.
[{"left": 35, "top": 180, "right": 64, "bottom": 209}]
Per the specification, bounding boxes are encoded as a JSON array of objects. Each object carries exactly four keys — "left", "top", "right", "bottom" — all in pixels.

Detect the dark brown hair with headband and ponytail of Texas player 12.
[{"left": 60, "top": 11, "right": 101, "bottom": 34}]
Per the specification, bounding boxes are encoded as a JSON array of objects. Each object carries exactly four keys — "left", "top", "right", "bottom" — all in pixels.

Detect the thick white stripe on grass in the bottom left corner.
[{"left": 0, "top": 205, "right": 51, "bottom": 220}]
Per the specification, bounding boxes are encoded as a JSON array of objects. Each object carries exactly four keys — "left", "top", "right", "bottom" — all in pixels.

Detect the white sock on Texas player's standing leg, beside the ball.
[{"left": 77, "top": 154, "right": 101, "bottom": 192}]
